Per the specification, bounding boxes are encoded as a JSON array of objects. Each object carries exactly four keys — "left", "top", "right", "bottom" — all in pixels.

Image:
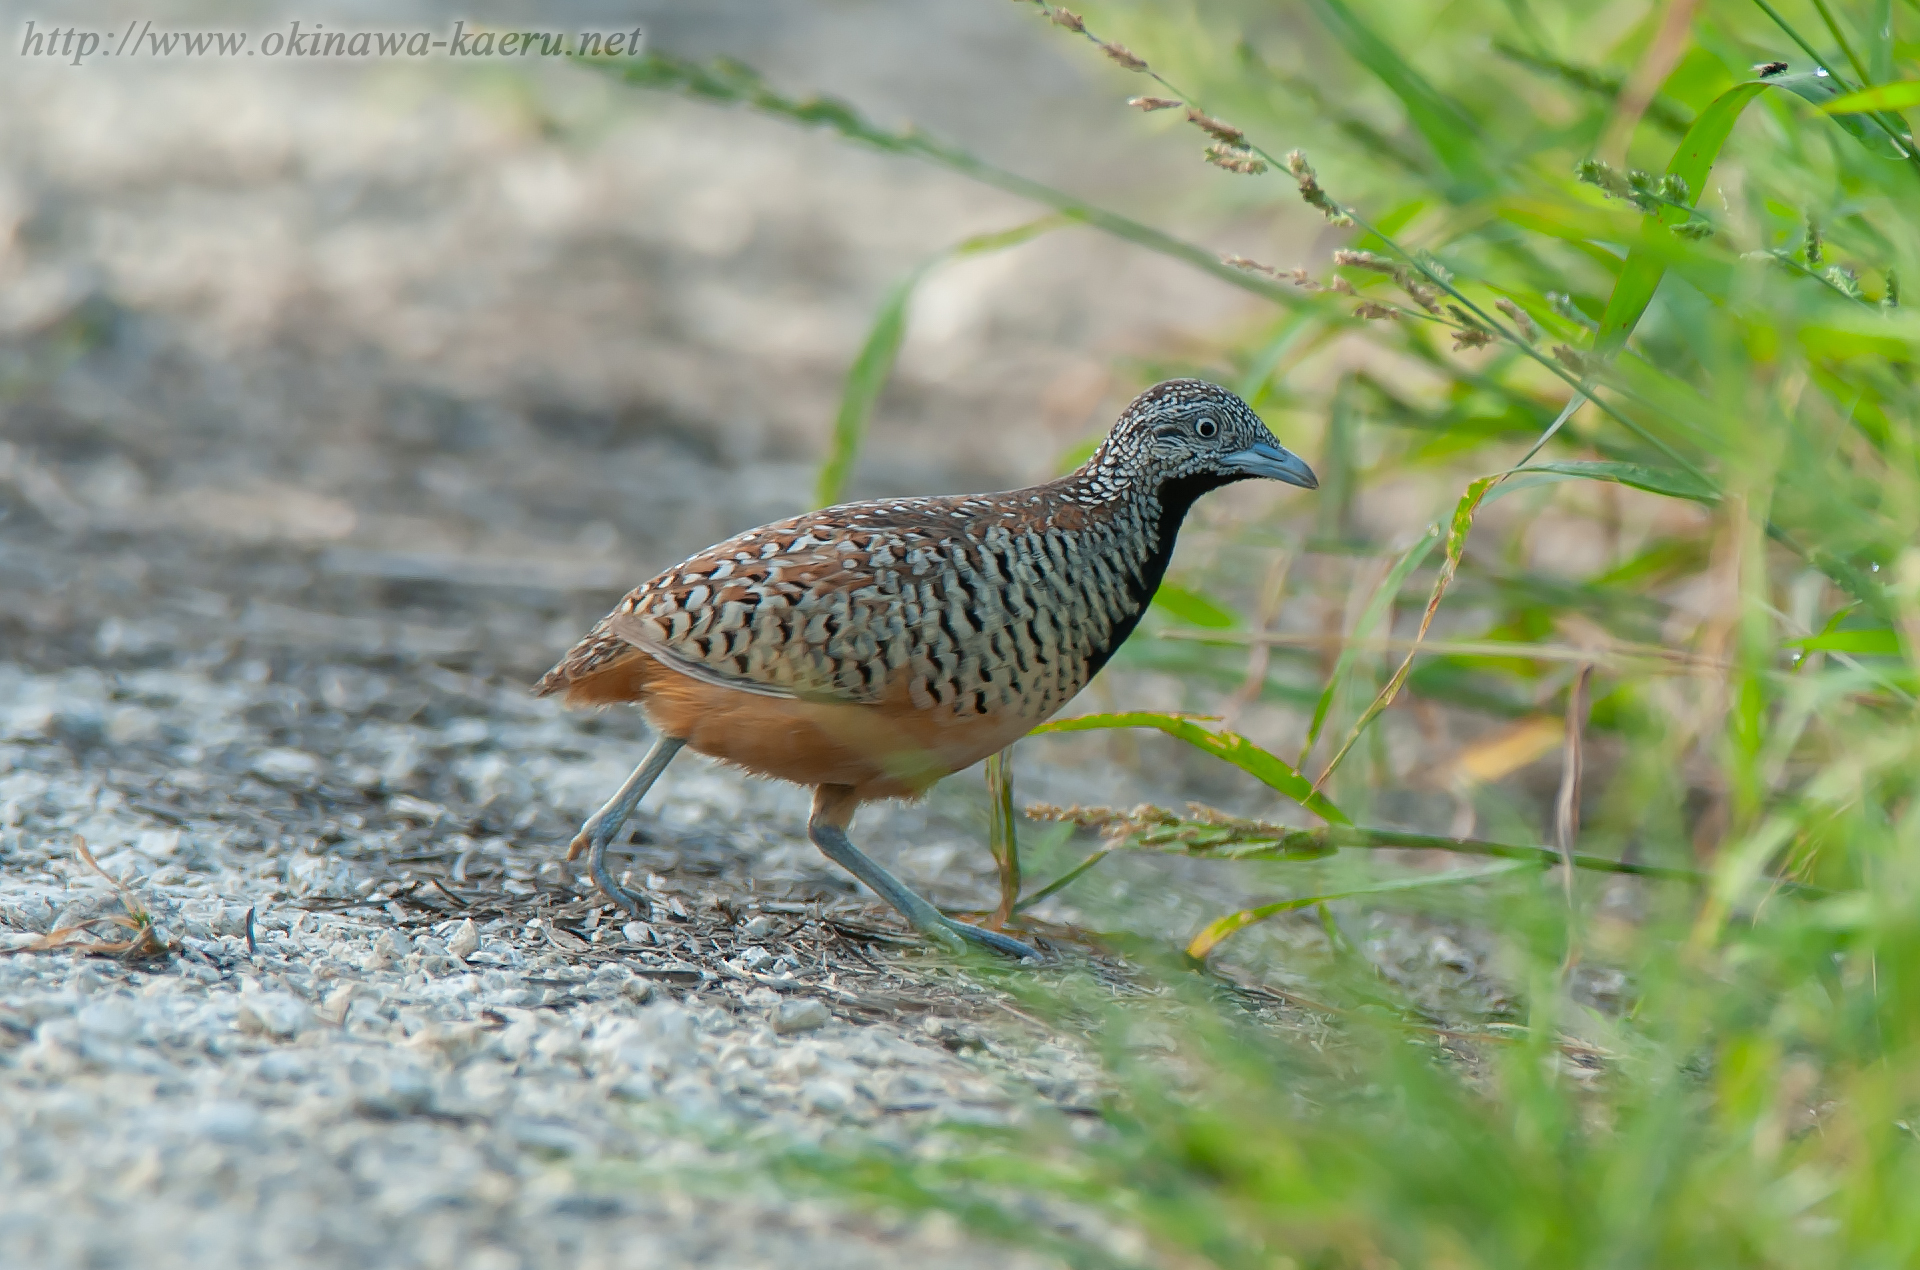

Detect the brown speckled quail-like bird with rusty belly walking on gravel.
[{"left": 536, "top": 379, "right": 1319, "bottom": 957}]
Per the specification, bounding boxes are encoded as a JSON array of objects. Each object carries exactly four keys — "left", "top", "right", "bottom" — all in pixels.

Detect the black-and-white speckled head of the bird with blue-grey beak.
[{"left": 1089, "top": 379, "right": 1319, "bottom": 494}]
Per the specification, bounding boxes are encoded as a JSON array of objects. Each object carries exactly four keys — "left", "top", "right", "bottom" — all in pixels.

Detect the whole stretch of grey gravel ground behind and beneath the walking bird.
[{"left": 0, "top": 0, "right": 1543, "bottom": 1270}]
